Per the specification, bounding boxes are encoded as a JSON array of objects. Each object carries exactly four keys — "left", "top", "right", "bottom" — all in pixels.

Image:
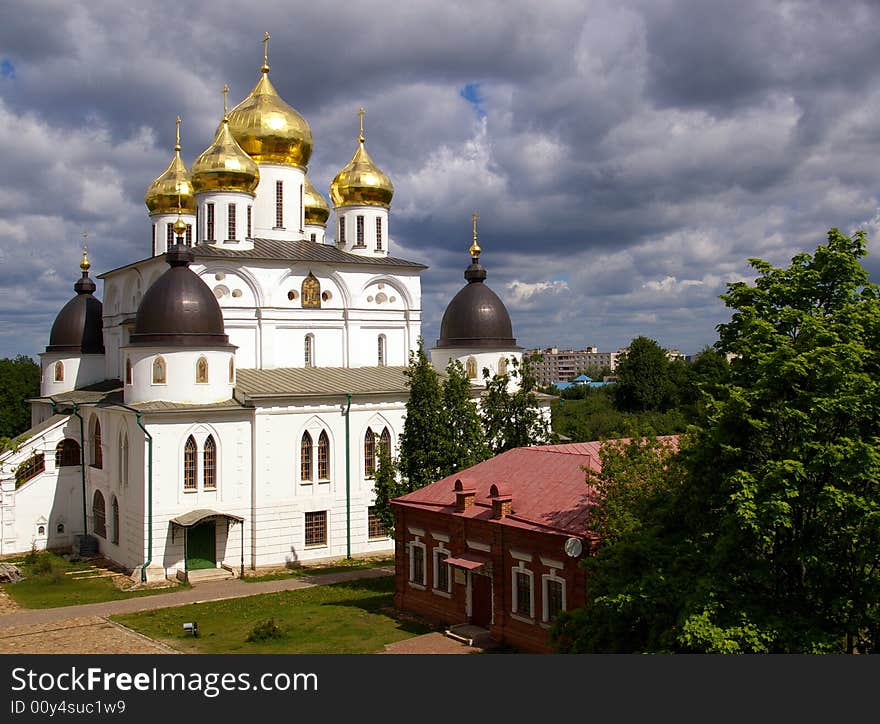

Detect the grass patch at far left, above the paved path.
[{"left": 3, "top": 552, "right": 186, "bottom": 608}]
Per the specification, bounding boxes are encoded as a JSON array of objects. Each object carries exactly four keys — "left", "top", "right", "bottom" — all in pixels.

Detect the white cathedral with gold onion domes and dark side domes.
[{"left": 0, "top": 38, "right": 521, "bottom": 581}]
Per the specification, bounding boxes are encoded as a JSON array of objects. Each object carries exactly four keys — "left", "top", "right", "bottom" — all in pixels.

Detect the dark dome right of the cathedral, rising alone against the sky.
[{"left": 437, "top": 259, "right": 516, "bottom": 347}]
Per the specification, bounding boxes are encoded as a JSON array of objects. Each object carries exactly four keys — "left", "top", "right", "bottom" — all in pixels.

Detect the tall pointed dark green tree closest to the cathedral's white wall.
[{"left": 397, "top": 338, "right": 446, "bottom": 492}]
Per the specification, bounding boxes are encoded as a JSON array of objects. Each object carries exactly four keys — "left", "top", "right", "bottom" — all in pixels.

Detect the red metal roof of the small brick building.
[{"left": 393, "top": 436, "right": 678, "bottom": 535}]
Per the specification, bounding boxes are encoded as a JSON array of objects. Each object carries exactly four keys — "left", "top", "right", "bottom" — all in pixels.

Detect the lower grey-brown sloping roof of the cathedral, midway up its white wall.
[{"left": 235, "top": 367, "right": 409, "bottom": 399}]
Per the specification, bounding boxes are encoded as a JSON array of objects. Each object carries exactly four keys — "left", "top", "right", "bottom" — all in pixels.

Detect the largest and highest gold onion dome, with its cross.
[{"left": 229, "top": 33, "right": 314, "bottom": 170}]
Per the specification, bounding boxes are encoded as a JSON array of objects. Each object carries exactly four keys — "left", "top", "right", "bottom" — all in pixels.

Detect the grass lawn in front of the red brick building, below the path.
[{"left": 112, "top": 576, "right": 432, "bottom": 654}]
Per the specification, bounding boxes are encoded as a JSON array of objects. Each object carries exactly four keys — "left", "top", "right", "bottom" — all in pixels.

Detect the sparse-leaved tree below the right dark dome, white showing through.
[{"left": 480, "top": 356, "right": 554, "bottom": 455}]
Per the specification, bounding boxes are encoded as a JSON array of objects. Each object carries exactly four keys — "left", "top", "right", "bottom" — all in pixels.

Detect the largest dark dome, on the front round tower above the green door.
[{"left": 131, "top": 244, "right": 229, "bottom": 347}]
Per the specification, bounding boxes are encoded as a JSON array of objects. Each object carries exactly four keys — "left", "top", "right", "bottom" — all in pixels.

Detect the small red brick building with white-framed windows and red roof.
[{"left": 392, "top": 442, "right": 601, "bottom": 652}]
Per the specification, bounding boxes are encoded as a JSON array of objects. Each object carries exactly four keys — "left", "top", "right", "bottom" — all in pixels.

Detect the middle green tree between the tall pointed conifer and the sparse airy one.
[{"left": 441, "top": 359, "right": 491, "bottom": 477}]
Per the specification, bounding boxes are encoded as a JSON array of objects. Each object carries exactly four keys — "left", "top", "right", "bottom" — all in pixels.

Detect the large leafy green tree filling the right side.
[{"left": 558, "top": 229, "right": 880, "bottom": 653}]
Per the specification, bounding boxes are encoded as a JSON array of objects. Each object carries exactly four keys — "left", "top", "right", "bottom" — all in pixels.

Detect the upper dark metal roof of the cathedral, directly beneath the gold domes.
[{"left": 98, "top": 238, "right": 428, "bottom": 279}]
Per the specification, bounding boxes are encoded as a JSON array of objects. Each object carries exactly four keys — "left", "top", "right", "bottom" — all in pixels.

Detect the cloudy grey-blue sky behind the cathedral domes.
[{"left": 0, "top": 0, "right": 880, "bottom": 356}]
